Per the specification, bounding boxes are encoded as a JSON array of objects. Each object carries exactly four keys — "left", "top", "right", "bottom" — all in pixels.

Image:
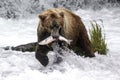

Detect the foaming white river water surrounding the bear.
[{"left": 0, "top": 8, "right": 120, "bottom": 80}]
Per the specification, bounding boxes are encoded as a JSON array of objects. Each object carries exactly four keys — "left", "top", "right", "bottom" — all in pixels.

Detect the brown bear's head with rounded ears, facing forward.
[{"left": 39, "top": 12, "right": 64, "bottom": 39}]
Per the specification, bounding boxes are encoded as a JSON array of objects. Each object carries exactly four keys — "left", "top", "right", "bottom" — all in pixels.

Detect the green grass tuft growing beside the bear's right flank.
[{"left": 90, "top": 21, "right": 108, "bottom": 55}]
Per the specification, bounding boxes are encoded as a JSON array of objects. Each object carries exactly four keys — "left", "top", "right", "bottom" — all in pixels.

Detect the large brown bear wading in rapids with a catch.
[{"left": 35, "top": 8, "right": 95, "bottom": 66}]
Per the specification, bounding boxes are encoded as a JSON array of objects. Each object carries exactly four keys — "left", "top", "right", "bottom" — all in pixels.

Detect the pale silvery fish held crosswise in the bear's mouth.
[{"left": 38, "top": 36, "right": 72, "bottom": 45}]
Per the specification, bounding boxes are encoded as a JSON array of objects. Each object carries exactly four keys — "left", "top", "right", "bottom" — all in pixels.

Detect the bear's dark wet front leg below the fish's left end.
[{"left": 35, "top": 44, "right": 51, "bottom": 66}]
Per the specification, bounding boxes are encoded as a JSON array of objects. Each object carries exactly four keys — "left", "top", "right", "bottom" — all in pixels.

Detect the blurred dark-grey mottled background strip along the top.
[{"left": 0, "top": 0, "right": 120, "bottom": 18}]
